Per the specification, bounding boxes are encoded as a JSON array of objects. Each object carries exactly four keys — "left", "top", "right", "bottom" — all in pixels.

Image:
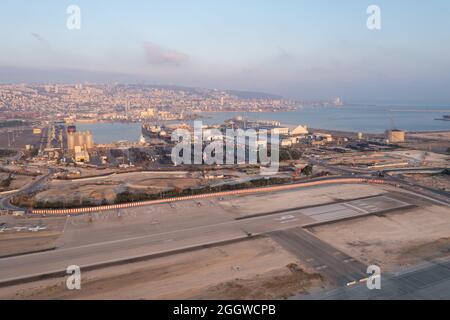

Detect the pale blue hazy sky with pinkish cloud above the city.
[{"left": 0, "top": 0, "right": 450, "bottom": 103}]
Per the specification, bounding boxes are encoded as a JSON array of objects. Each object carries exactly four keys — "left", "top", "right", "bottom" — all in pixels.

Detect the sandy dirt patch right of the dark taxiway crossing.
[{"left": 311, "top": 206, "right": 450, "bottom": 272}]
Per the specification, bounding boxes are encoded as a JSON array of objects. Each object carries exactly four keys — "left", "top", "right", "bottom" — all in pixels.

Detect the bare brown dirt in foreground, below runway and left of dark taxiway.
[{"left": 0, "top": 238, "right": 327, "bottom": 300}]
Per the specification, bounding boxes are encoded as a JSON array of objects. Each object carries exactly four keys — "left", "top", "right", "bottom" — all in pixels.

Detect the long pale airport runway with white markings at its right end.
[{"left": 0, "top": 196, "right": 408, "bottom": 284}]
